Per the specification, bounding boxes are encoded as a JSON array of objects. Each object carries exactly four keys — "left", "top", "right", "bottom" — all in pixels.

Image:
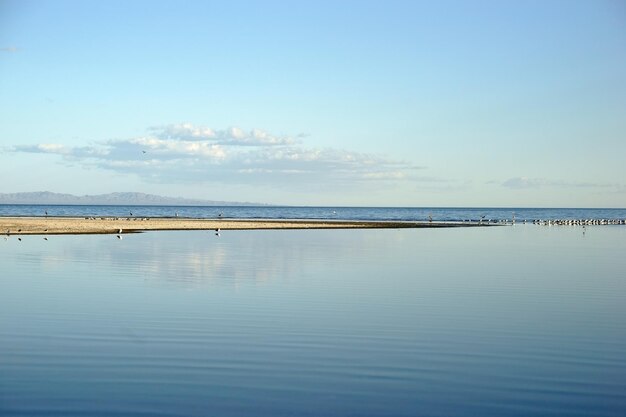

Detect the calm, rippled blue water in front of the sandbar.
[{"left": 0, "top": 225, "right": 626, "bottom": 416}]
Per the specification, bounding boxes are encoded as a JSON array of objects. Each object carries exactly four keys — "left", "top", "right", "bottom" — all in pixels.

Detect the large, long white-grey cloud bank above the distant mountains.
[{"left": 9, "top": 124, "right": 421, "bottom": 188}]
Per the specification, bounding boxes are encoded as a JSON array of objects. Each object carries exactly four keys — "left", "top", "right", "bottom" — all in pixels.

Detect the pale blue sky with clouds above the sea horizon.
[{"left": 0, "top": 0, "right": 626, "bottom": 207}]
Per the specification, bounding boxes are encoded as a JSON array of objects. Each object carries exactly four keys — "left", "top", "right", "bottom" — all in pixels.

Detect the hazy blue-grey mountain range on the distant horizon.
[{"left": 0, "top": 191, "right": 266, "bottom": 206}]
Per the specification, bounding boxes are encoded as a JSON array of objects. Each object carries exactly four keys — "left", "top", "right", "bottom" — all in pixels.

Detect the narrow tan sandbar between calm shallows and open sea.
[{"left": 0, "top": 217, "right": 478, "bottom": 235}]
